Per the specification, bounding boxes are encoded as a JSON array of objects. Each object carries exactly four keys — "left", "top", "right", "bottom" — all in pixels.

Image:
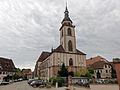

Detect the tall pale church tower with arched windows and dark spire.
[{"left": 60, "top": 5, "right": 76, "bottom": 53}]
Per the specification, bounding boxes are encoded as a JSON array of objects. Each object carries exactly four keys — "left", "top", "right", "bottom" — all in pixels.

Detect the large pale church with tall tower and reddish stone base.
[{"left": 34, "top": 6, "right": 86, "bottom": 79}]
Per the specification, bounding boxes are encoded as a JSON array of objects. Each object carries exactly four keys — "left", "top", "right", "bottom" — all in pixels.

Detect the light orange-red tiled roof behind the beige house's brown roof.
[{"left": 86, "top": 56, "right": 108, "bottom": 66}]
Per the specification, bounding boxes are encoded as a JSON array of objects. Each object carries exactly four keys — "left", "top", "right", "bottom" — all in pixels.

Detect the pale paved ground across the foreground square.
[{"left": 0, "top": 81, "right": 118, "bottom": 90}]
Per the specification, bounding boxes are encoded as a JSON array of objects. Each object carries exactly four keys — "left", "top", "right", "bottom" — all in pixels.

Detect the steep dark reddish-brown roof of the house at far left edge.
[{"left": 0, "top": 57, "right": 16, "bottom": 72}]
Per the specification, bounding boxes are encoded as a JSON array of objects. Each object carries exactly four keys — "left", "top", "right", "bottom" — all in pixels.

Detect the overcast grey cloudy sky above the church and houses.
[{"left": 0, "top": 0, "right": 120, "bottom": 70}]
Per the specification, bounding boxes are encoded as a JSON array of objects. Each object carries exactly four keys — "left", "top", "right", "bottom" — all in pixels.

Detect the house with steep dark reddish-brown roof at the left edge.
[{"left": 0, "top": 57, "right": 16, "bottom": 80}]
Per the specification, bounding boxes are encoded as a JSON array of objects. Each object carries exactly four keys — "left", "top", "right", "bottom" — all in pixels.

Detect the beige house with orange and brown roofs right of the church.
[{"left": 86, "top": 56, "right": 113, "bottom": 78}]
